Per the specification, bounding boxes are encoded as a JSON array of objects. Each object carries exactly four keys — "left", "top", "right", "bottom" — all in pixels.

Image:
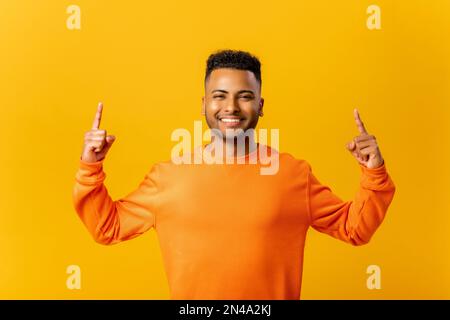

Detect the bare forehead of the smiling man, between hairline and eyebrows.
[{"left": 206, "top": 68, "right": 259, "bottom": 91}]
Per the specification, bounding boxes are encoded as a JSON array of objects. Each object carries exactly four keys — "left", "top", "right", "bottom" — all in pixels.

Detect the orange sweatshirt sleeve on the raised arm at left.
[{"left": 73, "top": 159, "right": 158, "bottom": 245}]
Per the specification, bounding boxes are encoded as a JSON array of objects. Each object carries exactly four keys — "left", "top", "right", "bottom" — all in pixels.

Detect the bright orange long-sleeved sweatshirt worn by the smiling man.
[{"left": 73, "top": 147, "right": 395, "bottom": 299}]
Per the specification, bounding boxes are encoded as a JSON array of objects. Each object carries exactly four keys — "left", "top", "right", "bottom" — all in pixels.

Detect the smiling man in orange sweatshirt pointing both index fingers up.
[{"left": 73, "top": 50, "right": 395, "bottom": 299}]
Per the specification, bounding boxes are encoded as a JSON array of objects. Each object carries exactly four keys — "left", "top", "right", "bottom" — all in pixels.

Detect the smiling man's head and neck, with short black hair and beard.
[{"left": 202, "top": 51, "right": 264, "bottom": 156}]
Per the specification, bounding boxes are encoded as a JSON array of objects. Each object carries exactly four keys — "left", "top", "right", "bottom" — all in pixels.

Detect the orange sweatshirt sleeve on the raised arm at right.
[{"left": 308, "top": 163, "right": 395, "bottom": 246}]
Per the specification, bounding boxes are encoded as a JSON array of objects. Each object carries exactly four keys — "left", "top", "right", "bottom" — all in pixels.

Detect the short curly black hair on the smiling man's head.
[{"left": 205, "top": 49, "right": 262, "bottom": 86}]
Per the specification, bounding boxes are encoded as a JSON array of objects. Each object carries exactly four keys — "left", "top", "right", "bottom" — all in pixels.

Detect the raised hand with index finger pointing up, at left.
[{"left": 81, "top": 102, "right": 116, "bottom": 163}]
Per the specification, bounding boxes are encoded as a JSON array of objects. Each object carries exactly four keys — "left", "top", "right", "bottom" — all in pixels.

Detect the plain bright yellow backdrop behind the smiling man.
[{"left": 0, "top": 0, "right": 450, "bottom": 299}]
